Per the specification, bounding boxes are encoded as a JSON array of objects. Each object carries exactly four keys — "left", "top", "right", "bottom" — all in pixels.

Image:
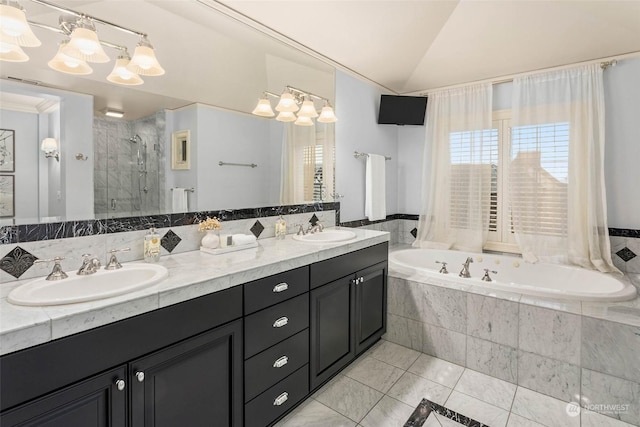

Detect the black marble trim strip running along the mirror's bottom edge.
[{"left": 0, "top": 202, "right": 340, "bottom": 245}]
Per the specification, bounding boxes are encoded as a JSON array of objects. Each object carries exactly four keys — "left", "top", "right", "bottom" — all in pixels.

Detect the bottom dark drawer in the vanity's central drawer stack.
[{"left": 244, "top": 365, "right": 309, "bottom": 427}]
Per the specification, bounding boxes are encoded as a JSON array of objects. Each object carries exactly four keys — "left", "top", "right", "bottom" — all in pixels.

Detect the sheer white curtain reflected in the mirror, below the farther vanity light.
[{"left": 280, "top": 123, "right": 335, "bottom": 205}]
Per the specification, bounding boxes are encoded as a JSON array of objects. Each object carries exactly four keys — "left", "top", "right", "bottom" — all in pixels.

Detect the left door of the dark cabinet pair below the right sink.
[{"left": 310, "top": 276, "right": 355, "bottom": 389}]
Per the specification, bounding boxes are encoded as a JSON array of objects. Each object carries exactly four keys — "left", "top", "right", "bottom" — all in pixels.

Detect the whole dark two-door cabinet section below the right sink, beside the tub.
[{"left": 309, "top": 244, "right": 387, "bottom": 390}]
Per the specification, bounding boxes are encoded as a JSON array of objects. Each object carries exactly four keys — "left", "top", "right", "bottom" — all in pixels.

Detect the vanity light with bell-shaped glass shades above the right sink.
[{"left": 252, "top": 86, "right": 338, "bottom": 126}]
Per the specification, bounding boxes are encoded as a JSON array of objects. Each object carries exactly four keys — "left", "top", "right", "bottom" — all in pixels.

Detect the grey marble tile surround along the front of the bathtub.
[{"left": 385, "top": 246, "right": 640, "bottom": 424}]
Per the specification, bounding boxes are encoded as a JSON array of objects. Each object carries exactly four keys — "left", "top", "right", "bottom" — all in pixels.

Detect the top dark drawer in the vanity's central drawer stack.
[{"left": 244, "top": 266, "right": 309, "bottom": 315}]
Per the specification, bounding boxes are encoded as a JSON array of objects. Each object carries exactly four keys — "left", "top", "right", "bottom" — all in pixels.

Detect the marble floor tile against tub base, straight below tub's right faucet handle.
[{"left": 454, "top": 369, "right": 517, "bottom": 411}]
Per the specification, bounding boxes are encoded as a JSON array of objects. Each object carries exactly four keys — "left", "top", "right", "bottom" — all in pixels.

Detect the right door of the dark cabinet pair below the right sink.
[{"left": 354, "top": 263, "right": 387, "bottom": 354}]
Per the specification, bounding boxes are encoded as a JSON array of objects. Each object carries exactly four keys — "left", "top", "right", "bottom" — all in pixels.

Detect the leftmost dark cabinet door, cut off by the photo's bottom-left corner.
[{"left": 0, "top": 366, "right": 128, "bottom": 427}]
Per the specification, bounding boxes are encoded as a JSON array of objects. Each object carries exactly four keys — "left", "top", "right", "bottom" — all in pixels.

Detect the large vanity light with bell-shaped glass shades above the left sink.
[{"left": 0, "top": 0, "right": 165, "bottom": 86}]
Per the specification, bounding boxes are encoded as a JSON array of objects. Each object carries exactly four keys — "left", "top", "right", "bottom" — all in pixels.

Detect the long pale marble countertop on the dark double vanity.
[{"left": 0, "top": 227, "right": 389, "bottom": 355}]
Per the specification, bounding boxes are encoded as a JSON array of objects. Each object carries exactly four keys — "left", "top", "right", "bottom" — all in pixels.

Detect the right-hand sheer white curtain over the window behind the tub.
[{"left": 509, "top": 64, "right": 618, "bottom": 272}]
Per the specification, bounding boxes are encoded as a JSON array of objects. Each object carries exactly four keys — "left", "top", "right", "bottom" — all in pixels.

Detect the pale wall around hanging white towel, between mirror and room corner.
[{"left": 335, "top": 71, "right": 398, "bottom": 222}]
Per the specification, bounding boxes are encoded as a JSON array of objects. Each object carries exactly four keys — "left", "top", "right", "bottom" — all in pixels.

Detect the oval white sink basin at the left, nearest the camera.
[{"left": 7, "top": 263, "right": 169, "bottom": 306}]
